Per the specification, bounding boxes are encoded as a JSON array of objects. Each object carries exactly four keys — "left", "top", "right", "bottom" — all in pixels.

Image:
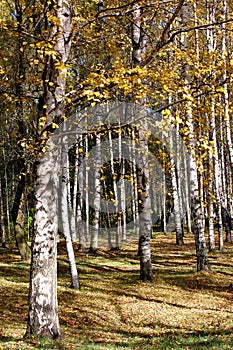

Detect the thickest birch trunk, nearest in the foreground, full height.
[{"left": 26, "top": 0, "right": 72, "bottom": 339}]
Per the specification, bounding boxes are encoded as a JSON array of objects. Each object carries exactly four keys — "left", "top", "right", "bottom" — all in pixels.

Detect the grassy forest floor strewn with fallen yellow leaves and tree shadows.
[{"left": 0, "top": 234, "right": 233, "bottom": 350}]
